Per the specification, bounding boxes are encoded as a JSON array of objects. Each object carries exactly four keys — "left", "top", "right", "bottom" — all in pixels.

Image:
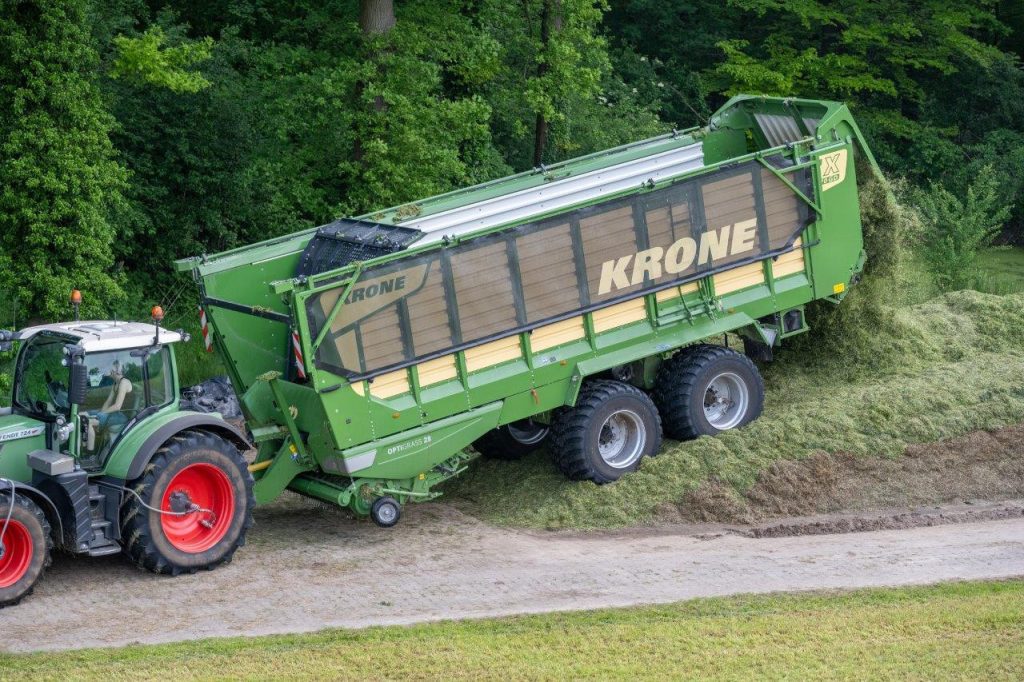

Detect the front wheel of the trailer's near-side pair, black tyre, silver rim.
[{"left": 549, "top": 380, "right": 662, "bottom": 485}]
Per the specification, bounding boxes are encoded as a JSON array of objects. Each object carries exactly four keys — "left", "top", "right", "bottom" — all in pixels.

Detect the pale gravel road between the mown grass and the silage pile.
[{"left": 6, "top": 495, "right": 1024, "bottom": 651}]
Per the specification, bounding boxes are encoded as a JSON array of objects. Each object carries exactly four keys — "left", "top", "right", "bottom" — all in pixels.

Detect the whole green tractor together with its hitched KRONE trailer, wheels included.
[{"left": 0, "top": 96, "right": 874, "bottom": 605}]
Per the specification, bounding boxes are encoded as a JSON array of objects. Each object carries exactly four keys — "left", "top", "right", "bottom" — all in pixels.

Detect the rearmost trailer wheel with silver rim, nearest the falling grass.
[{"left": 653, "top": 345, "right": 765, "bottom": 440}]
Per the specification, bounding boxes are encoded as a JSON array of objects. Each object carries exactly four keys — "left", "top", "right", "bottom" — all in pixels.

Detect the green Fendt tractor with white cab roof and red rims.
[{"left": 0, "top": 311, "right": 255, "bottom": 606}]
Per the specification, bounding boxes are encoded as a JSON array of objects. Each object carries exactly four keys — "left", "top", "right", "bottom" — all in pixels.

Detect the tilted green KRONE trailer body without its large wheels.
[{"left": 178, "top": 96, "right": 876, "bottom": 512}]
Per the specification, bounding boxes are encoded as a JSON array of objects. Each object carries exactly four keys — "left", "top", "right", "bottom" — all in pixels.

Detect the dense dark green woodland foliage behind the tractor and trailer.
[{"left": 0, "top": 0, "right": 1024, "bottom": 325}]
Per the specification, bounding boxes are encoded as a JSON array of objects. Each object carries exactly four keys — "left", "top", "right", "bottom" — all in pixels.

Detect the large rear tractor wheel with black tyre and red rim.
[{"left": 121, "top": 431, "right": 256, "bottom": 576}]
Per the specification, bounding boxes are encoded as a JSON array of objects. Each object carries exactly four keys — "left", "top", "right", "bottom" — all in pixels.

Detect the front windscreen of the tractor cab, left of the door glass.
[{"left": 14, "top": 334, "right": 71, "bottom": 417}]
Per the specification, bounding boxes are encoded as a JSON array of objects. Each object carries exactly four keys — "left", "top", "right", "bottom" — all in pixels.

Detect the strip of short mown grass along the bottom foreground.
[{"left": 0, "top": 581, "right": 1024, "bottom": 680}]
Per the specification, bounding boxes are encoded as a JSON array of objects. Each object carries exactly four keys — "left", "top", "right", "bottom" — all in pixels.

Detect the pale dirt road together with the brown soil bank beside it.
[{"left": 0, "top": 419, "right": 1024, "bottom": 651}]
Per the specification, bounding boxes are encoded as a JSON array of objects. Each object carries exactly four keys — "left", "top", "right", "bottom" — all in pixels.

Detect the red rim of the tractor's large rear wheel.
[{"left": 160, "top": 464, "right": 234, "bottom": 554}]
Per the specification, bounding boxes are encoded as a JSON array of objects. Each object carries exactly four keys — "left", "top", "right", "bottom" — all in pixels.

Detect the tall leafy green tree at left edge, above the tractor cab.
[{"left": 0, "top": 0, "right": 126, "bottom": 318}]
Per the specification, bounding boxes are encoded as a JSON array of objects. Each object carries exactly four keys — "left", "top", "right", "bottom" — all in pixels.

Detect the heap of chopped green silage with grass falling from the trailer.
[{"left": 449, "top": 178, "right": 1024, "bottom": 528}]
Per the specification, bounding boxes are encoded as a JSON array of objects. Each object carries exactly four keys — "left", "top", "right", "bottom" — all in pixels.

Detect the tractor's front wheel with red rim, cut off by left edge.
[{"left": 0, "top": 491, "right": 53, "bottom": 608}]
